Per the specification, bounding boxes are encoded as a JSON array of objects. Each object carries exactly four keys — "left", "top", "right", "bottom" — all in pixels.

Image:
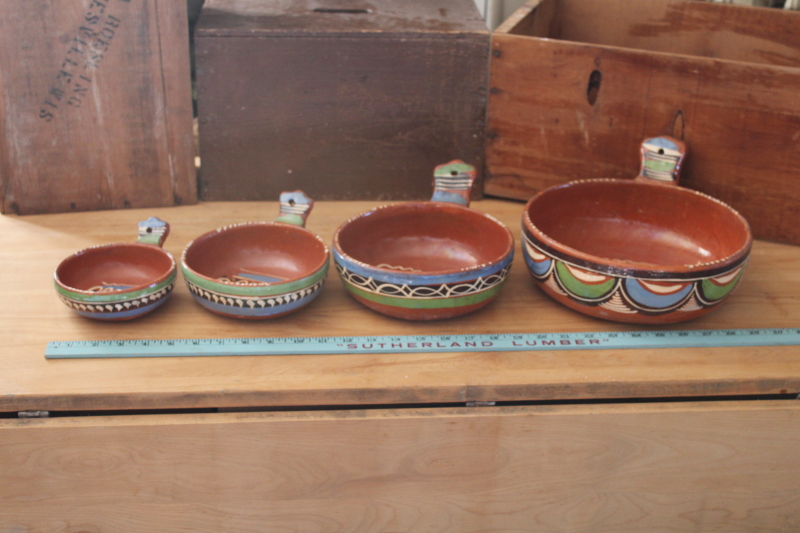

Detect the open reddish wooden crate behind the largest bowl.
[{"left": 485, "top": 0, "right": 800, "bottom": 243}]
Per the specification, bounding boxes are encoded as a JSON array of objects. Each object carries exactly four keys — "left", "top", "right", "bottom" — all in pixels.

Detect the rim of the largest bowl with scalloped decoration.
[{"left": 522, "top": 178, "right": 753, "bottom": 279}]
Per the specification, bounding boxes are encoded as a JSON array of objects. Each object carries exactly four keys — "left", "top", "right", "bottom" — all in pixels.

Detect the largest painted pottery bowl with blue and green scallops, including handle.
[{"left": 522, "top": 137, "right": 752, "bottom": 324}]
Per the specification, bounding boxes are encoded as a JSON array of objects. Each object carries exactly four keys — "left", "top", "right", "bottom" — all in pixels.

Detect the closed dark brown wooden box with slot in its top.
[{"left": 195, "top": 0, "right": 489, "bottom": 200}]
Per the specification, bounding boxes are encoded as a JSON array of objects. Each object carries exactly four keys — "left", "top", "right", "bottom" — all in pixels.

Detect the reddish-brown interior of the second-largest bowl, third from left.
[{"left": 337, "top": 202, "right": 513, "bottom": 273}]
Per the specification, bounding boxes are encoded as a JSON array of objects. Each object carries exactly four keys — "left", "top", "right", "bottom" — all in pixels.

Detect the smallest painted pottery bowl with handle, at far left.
[{"left": 54, "top": 218, "right": 178, "bottom": 320}]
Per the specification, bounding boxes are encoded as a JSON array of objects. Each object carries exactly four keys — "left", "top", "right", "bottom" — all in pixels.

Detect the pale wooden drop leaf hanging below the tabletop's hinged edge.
[{"left": 0, "top": 401, "right": 800, "bottom": 533}]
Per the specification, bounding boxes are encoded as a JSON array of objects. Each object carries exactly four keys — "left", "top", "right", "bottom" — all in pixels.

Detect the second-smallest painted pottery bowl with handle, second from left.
[{"left": 181, "top": 191, "right": 329, "bottom": 319}]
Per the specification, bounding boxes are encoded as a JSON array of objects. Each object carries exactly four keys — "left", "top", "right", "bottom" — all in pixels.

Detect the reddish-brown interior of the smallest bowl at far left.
[{"left": 56, "top": 243, "right": 175, "bottom": 291}]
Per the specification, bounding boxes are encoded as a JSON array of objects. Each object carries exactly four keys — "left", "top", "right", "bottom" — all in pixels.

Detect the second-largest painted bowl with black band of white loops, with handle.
[{"left": 333, "top": 161, "right": 514, "bottom": 320}]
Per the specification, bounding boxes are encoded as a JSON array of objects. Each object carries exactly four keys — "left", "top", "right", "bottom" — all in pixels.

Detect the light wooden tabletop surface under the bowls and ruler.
[{"left": 0, "top": 200, "right": 800, "bottom": 412}]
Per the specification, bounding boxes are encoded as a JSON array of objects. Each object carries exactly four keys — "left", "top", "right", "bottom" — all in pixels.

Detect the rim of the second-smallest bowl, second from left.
[{"left": 181, "top": 221, "right": 330, "bottom": 288}]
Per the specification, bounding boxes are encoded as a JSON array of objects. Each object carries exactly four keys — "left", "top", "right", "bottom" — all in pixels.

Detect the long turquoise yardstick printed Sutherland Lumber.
[{"left": 45, "top": 328, "right": 800, "bottom": 359}]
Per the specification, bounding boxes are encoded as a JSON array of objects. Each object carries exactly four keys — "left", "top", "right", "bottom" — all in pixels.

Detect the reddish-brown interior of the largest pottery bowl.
[{"left": 527, "top": 180, "right": 750, "bottom": 267}]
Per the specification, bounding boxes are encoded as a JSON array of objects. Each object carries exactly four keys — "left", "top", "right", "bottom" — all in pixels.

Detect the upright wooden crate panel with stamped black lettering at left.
[{"left": 0, "top": 0, "right": 197, "bottom": 214}]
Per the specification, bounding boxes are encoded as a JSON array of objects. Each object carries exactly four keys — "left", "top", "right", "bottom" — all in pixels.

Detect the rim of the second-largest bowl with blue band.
[{"left": 333, "top": 201, "right": 514, "bottom": 279}]
